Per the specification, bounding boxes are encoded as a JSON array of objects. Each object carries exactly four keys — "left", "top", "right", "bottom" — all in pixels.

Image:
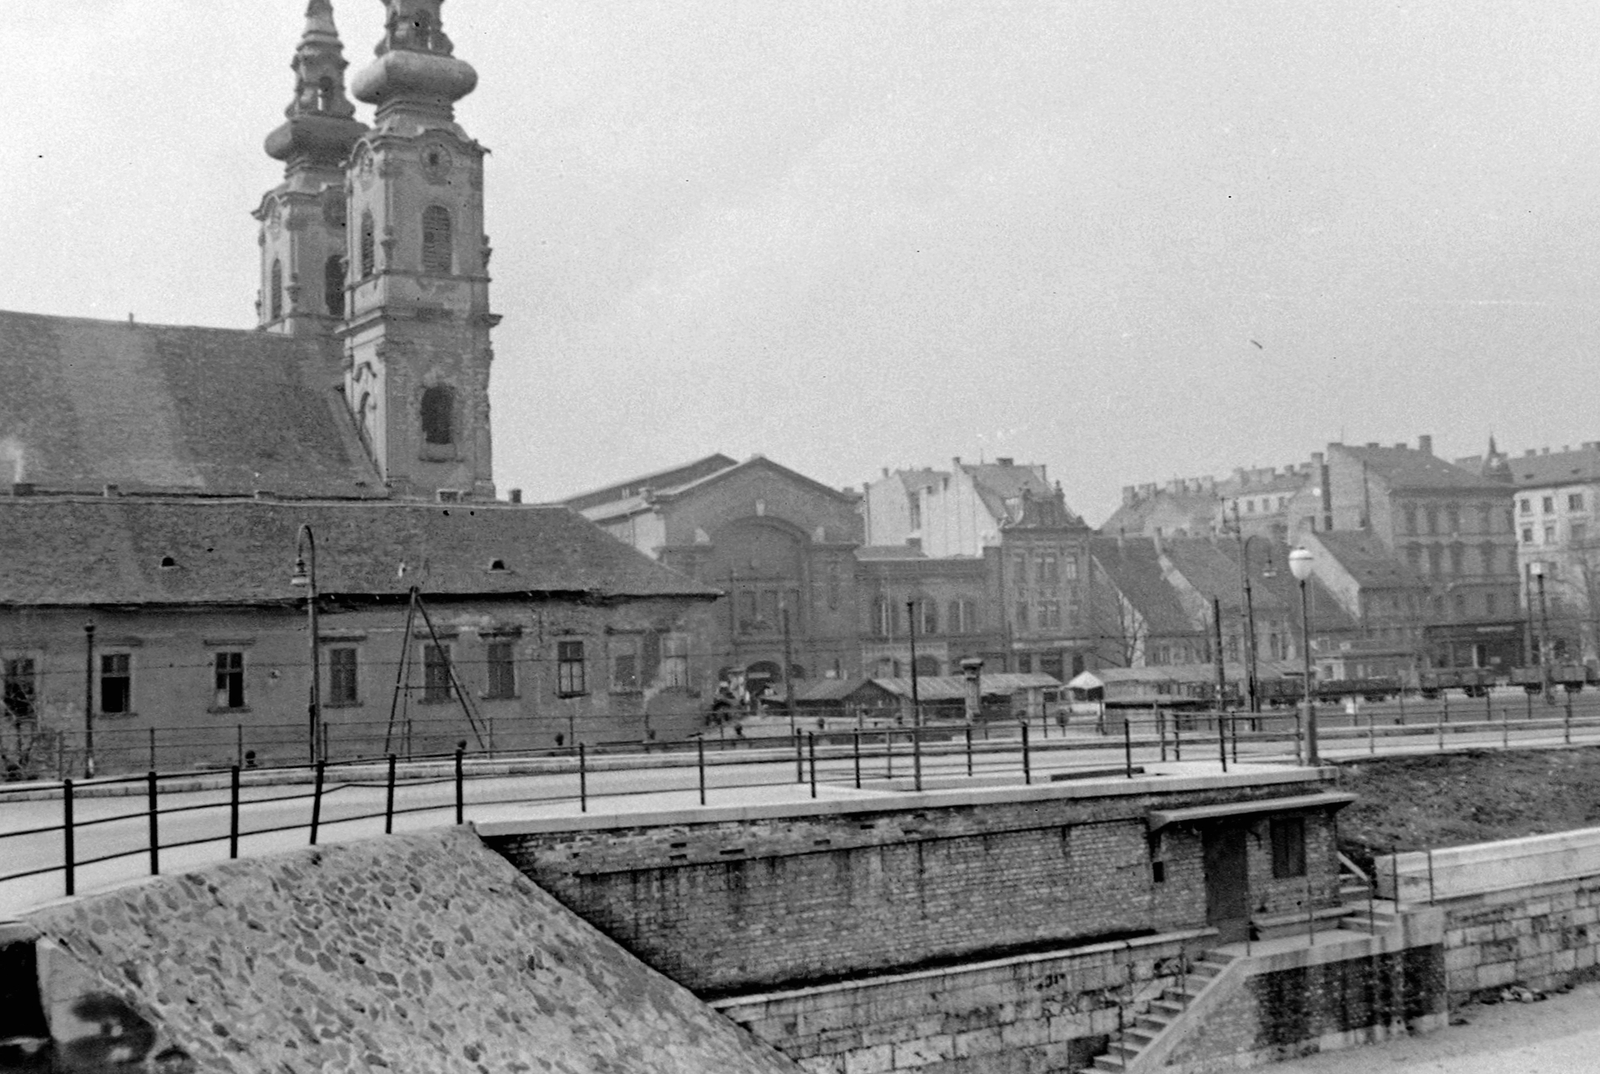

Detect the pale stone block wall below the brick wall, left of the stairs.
[{"left": 714, "top": 930, "right": 1214, "bottom": 1074}]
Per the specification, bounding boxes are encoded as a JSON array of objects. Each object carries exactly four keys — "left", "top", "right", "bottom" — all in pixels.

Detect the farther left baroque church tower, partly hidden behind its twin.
[{"left": 254, "top": 0, "right": 366, "bottom": 336}]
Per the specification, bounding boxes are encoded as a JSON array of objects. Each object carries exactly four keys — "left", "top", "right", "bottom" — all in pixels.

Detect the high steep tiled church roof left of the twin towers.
[{"left": 0, "top": 312, "right": 387, "bottom": 498}]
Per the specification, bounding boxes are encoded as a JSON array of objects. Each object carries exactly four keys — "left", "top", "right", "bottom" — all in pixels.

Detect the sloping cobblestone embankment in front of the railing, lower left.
[{"left": 27, "top": 829, "right": 798, "bottom": 1074}]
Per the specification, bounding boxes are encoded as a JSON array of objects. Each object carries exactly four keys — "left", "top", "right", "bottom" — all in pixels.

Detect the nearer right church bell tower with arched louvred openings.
[{"left": 347, "top": 0, "right": 499, "bottom": 499}]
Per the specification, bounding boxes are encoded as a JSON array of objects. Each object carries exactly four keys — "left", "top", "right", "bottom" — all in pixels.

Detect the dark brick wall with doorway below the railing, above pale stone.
[{"left": 488, "top": 784, "right": 1338, "bottom": 994}]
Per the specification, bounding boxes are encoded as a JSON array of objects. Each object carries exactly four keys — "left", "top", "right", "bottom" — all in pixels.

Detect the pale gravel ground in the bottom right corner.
[{"left": 1266, "top": 984, "right": 1600, "bottom": 1074}]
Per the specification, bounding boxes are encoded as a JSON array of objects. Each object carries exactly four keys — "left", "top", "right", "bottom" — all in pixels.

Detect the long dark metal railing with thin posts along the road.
[{"left": 0, "top": 709, "right": 1600, "bottom": 915}]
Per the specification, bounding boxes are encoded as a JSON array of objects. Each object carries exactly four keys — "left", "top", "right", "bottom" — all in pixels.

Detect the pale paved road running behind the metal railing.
[{"left": 0, "top": 717, "right": 1600, "bottom": 912}]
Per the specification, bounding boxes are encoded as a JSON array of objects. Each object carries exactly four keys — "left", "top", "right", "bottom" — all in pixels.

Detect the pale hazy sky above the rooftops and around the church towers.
[{"left": 0, "top": 0, "right": 1600, "bottom": 525}]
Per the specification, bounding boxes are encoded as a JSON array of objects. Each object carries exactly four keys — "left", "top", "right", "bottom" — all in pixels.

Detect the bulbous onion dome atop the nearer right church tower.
[{"left": 352, "top": 0, "right": 478, "bottom": 125}]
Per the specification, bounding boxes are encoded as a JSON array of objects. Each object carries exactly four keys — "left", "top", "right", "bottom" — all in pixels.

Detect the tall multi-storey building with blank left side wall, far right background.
[{"left": 1306, "top": 435, "right": 1525, "bottom": 671}]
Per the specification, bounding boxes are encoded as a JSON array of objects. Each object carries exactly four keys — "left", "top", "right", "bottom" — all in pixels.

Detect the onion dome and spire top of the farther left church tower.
[{"left": 267, "top": 0, "right": 366, "bottom": 165}]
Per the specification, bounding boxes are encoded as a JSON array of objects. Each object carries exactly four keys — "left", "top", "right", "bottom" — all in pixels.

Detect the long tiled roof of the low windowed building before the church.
[{"left": 0, "top": 496, "right": 718, "bottom": 605}]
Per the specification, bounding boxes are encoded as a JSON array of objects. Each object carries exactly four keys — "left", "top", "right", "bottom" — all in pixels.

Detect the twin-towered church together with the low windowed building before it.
[{"left": 0, "top": 0, "right": 722, "bottom": 778}]
